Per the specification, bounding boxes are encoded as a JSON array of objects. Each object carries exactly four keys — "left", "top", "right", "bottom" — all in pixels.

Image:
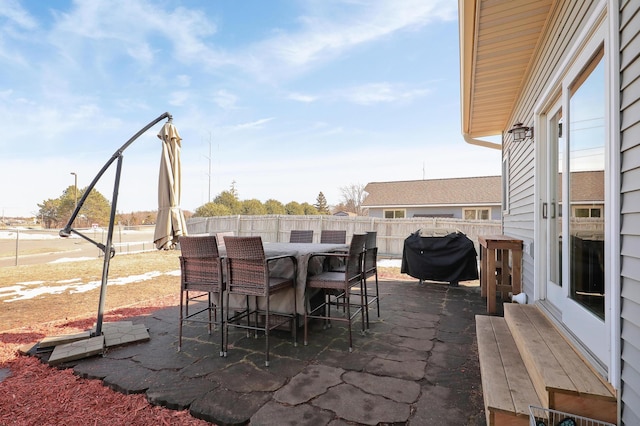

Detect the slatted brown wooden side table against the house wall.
[{"left": 478, "top": 235, "right": 522, "bottom": 314}]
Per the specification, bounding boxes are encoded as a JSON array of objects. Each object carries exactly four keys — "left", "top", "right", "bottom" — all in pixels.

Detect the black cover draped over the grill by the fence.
[{"left": 400, "top": 230, "right": 478, "bottom": 283}]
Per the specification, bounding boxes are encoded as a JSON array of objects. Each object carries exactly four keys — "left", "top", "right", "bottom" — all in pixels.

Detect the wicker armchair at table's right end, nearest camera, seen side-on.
[{"left": 304, "top": 234, "right": 366, "bottom": 352}]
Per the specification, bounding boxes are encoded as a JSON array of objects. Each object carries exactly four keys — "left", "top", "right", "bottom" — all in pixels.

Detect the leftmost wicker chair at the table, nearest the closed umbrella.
[{"left": 178, "top": 235, "right": 225, "bottom": 356}]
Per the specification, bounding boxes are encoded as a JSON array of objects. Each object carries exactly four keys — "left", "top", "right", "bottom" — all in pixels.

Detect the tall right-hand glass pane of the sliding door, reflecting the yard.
[{"left": 568, "top": 54, "right": 606, "bottom": 318}]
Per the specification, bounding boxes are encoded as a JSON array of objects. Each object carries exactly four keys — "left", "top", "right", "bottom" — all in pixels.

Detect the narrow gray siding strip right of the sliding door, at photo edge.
[{"left": 619, "top": 1, "right": 640, "bottom": 425}]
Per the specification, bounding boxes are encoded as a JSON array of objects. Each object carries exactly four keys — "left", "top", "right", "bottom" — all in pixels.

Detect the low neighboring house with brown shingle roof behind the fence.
[{"left": 362, "top": 176, "right": 501, "bottom": 220}]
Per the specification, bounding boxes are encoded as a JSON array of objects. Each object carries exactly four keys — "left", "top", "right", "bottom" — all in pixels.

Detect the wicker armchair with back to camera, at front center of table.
[{"left": 224, "top": 237, "right": 298, "bottom": 367}]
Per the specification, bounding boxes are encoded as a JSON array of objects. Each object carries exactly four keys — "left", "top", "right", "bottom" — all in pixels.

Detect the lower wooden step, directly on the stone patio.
[{"left": 476, "top": 315, "right": 540, "bottom": 426}]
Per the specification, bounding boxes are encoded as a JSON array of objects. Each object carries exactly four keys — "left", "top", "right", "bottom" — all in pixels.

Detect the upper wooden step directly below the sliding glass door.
[{"left": 504, "top": 303, "right": 617, "bottom": 423}]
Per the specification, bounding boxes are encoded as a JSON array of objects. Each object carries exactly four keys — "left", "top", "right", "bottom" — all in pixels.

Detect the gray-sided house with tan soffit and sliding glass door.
[{"left": 459, "top": 0, "right": 640, "bottom": 425}]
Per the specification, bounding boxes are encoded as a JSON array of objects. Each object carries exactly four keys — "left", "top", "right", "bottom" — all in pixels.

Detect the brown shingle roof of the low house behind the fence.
[{"left": 363, "top": 176, "right": 502, "bottom": 207}]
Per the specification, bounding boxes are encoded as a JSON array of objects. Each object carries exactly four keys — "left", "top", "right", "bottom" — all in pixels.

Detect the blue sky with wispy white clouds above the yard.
[{"left": 0, "top": 0, "right": 501, "bottom": 217}]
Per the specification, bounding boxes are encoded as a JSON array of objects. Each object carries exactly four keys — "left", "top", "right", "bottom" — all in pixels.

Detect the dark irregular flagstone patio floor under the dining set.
[{"left": 39, "top": 281, "right": 486, "bottom": 426}]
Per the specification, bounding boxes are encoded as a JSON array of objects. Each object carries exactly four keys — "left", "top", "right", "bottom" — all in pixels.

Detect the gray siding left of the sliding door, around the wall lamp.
[{"left": 503, "top": 0, "right": 594, "bottom": 296}]
